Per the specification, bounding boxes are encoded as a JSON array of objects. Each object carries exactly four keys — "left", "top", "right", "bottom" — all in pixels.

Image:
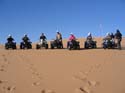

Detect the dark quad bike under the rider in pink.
[{"left": 67, "top": 40, "right": 80, "bottom": 50}]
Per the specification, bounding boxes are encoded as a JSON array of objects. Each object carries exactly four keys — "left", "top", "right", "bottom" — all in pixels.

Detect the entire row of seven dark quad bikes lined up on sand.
[{"left": 5, "top": 40, "right": 121, "bottom": 50}]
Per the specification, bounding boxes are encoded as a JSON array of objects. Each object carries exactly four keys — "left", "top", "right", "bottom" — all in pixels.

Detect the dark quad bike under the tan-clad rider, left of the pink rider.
[{"left": 50, "top": 40, "right": 63, "bottom": 49}]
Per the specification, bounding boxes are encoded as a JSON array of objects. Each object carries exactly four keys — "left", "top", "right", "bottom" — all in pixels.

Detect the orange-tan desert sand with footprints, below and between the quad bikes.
[{"left": 0, "top": 38, "right": 125, "bottom": 93}]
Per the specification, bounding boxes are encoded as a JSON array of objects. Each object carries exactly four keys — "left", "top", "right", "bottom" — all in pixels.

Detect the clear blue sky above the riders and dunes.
[{"left": 0, "top": 0, "right": 125, "bottom": 43}]
